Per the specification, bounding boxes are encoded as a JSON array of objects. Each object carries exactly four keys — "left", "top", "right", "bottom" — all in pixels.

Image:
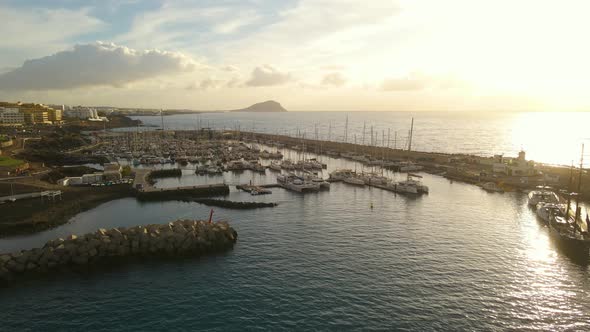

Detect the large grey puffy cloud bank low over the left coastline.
[{"left": 0, "top": 42, "right": 197, "bottom": 90}]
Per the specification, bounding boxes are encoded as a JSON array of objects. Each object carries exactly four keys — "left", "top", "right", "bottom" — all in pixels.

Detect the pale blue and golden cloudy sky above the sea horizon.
[{"left": 0, "top": 0, "right": 590, "bottom": 111}]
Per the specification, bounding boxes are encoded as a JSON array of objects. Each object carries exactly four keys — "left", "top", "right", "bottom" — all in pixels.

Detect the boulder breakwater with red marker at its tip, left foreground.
[{"left": 0, "top": 220, "right": 238, "bottom": 281}]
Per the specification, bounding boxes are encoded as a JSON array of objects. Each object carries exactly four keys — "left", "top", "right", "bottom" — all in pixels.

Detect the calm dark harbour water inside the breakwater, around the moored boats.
[{"left": 0, "top": 151, "right": 590, "bottom": 331}]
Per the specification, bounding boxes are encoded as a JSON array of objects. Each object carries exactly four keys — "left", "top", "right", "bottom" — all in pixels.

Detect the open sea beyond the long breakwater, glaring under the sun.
[{"left": 128, "top": 112, "right": 590, "bottom": 165}]
